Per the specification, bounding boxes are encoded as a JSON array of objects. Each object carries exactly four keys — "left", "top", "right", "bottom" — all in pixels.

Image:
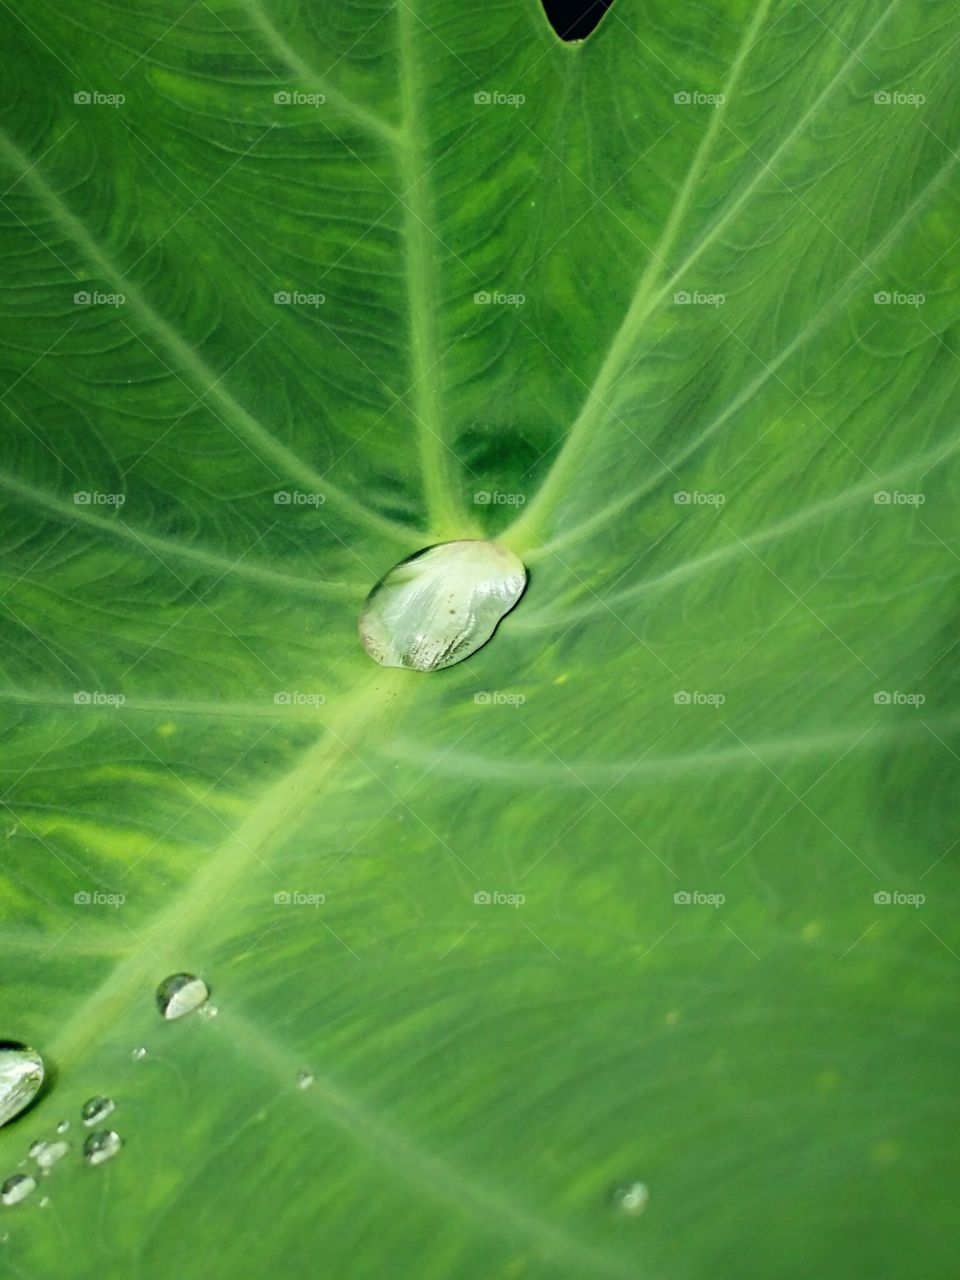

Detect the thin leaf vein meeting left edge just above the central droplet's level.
[{"left": 0, "top": 471, "right": 367, "bottom": 600}]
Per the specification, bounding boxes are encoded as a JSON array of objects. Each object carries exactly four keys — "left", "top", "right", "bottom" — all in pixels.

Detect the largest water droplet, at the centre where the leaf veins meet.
[{"left": 358, "top": 540, "right": 526, "bottom": 671}]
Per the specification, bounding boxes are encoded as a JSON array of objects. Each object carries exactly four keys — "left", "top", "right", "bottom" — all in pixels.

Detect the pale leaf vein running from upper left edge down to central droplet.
[{"left": 0, "top": 129, "right": 422, "bottom": 547}]
